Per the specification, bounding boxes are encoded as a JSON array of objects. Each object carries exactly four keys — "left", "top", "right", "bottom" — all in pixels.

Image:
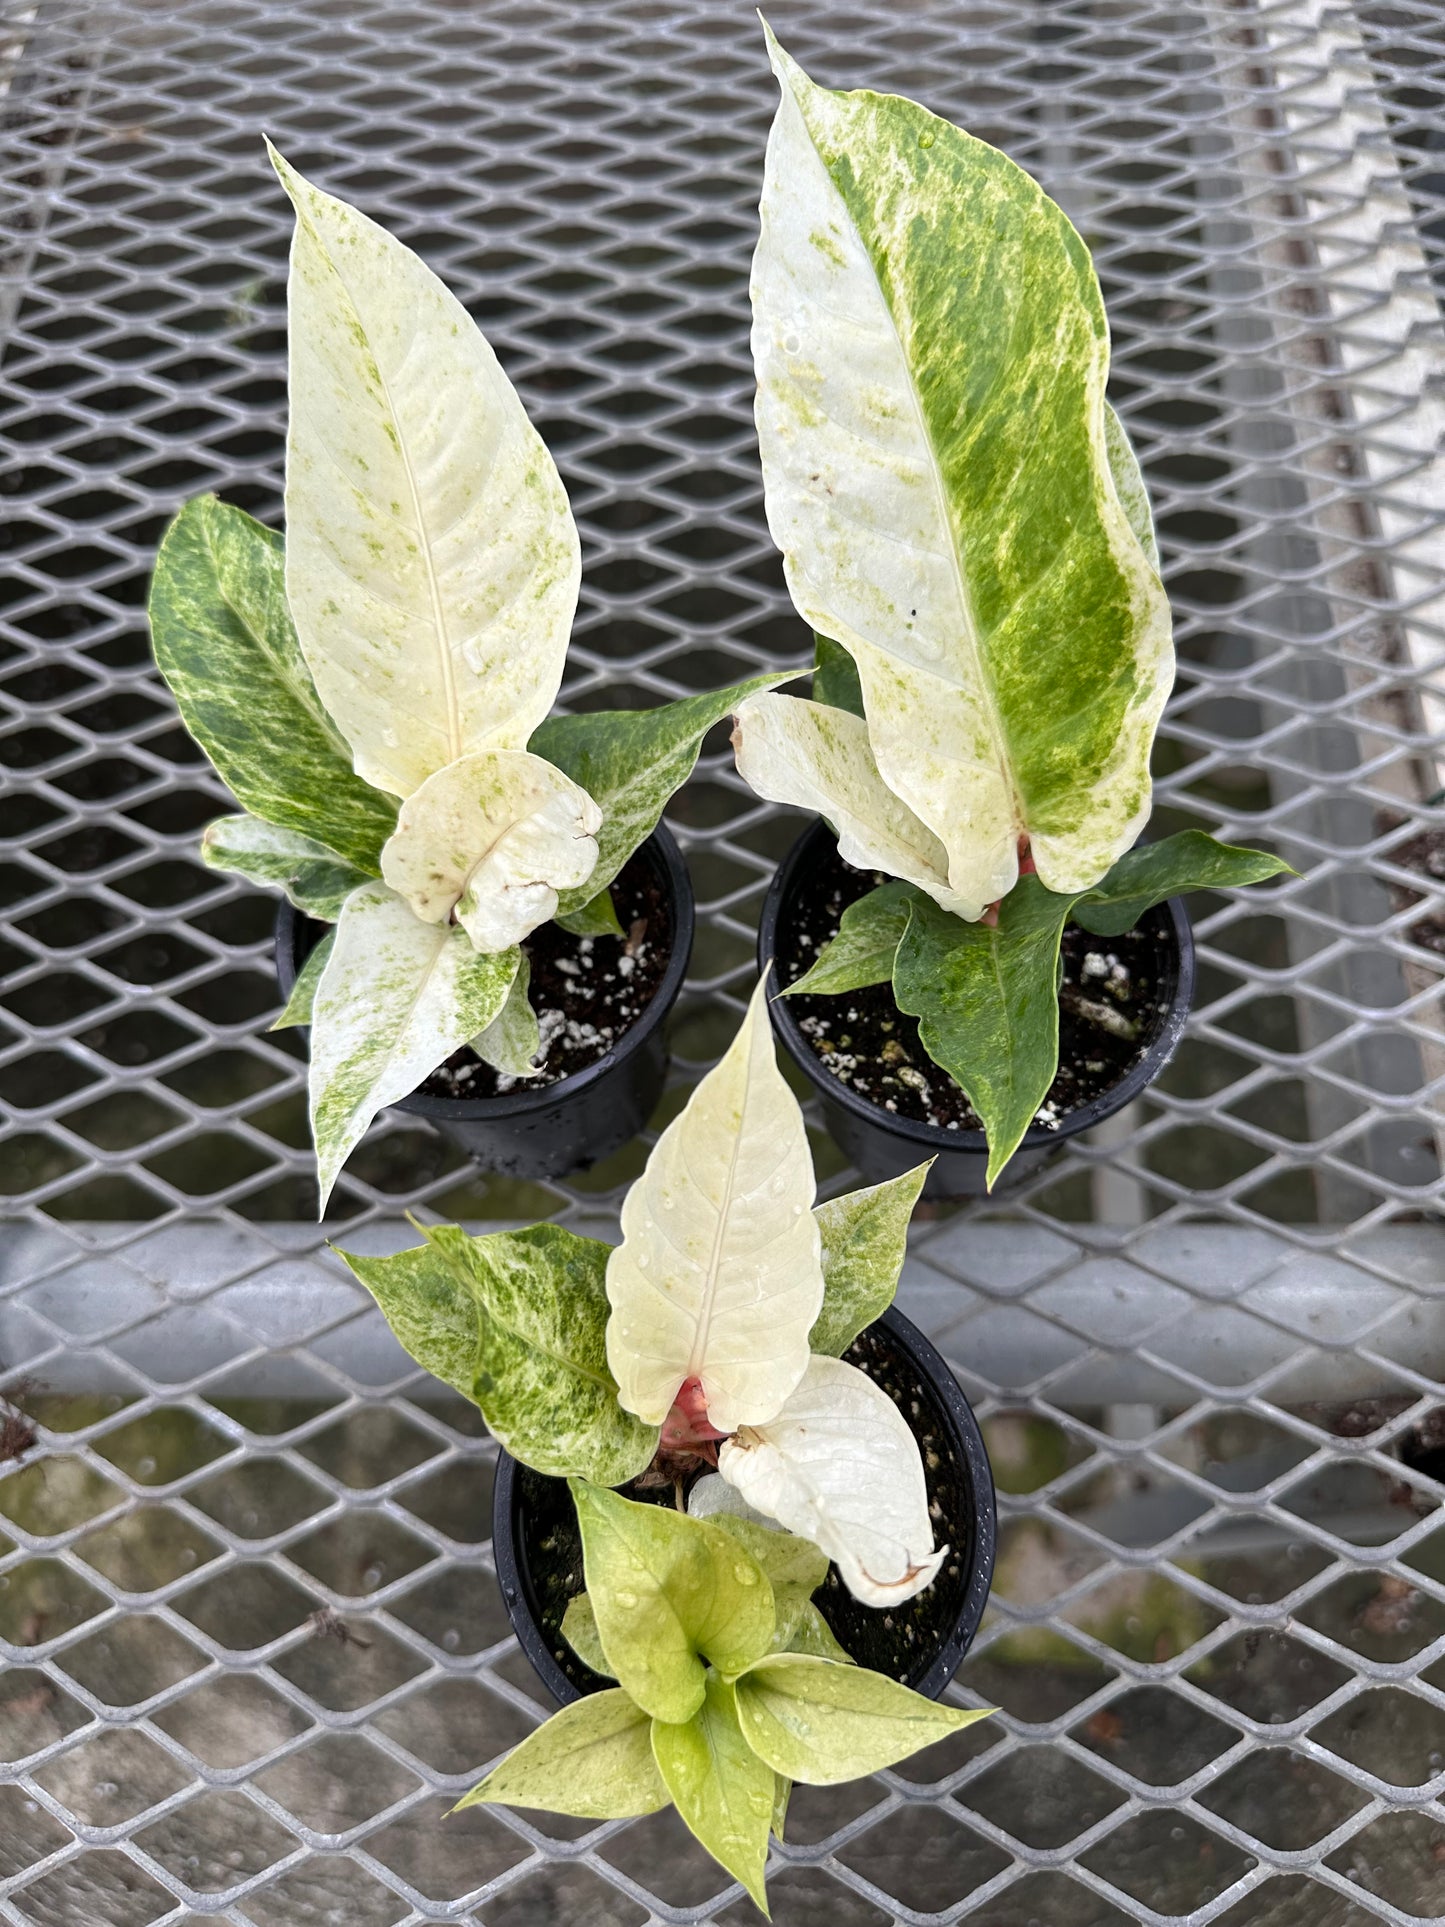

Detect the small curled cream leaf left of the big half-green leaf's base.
[{"left": 732, "top": 696, "right": 969, "bottom": 915}]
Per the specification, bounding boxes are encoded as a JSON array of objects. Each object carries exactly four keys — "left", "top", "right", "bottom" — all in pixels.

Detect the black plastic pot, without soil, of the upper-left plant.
[{"left": 276, "top": 823, "right": 694, "bottom": 1177}]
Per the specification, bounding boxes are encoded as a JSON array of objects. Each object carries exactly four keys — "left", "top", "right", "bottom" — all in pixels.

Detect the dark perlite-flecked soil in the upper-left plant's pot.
[{"left": 304, "top": 844, "right": 672, "bottom": 1098}]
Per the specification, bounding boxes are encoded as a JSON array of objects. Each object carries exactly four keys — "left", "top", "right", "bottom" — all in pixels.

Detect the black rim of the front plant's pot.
[{"left": 491, "top": 1305, "right": 998, "bottom": 1705}]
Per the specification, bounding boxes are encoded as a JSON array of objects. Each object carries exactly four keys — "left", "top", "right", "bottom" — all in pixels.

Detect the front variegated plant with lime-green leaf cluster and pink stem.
[{"left": 343, "top": 985, "right": 983, "bottom": 1906}]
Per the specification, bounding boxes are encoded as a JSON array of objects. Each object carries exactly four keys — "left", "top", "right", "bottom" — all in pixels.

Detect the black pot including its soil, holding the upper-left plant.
[{"left": 276, "top": 823, "right": 694, "bottom": 1177}]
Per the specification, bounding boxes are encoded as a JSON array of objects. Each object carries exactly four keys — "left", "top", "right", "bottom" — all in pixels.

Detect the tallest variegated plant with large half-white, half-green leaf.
[{"left": 734, "top": 35, "right": 1287, "bottom": 1185}]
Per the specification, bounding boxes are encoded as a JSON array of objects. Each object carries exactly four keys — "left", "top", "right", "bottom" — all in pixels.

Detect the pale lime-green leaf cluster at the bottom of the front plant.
[{"left": 460, "top": 1480, "right": 986, "bottom": 1914}]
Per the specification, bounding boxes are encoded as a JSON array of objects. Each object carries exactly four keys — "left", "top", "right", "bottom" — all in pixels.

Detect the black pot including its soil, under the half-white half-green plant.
[{"left": 757, "top": 823, "right": 1195, "bottom": 1199}]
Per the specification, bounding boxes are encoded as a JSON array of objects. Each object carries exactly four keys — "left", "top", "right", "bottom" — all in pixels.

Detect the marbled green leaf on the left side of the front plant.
[{"left": 341, "top": 1224, "right": 657, "bottom": 1486}]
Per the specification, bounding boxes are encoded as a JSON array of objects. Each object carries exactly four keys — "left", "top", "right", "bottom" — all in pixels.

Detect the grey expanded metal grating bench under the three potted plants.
[{"left": 0, "top": 0, "right": 1445, "bottom": 1927}]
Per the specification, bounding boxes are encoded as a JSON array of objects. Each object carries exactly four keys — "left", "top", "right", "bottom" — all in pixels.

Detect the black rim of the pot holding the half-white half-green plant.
[{"left": 757, "top": 817, "right": 1195, "bottom": 1156}]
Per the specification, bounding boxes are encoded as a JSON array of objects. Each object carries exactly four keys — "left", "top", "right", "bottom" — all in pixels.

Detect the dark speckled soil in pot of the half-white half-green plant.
[{"left": 778, "top": 850, "right": 1171, "bottom": 1131}]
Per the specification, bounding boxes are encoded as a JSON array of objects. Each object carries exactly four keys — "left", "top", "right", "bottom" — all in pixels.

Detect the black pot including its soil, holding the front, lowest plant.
[{"left": 491, "top": 1307, "right": 996, "bottom": 1705}]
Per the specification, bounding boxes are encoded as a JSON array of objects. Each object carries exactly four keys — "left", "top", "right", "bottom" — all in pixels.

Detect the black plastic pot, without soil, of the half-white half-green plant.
[{"left": 757, "top": 821, "right": 1195, "bottom": 1199}]
